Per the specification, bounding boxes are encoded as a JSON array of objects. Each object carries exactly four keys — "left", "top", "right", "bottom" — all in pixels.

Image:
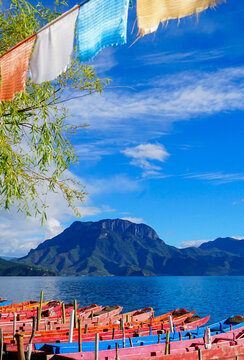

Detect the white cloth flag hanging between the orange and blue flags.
[{"left": 30, "top": 5, "right": 79, "bottom": 84}]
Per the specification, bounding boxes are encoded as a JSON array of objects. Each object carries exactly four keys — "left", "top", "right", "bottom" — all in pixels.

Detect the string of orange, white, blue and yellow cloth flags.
[{"left": 0, "top": 0, "right": 224, "bottom": 102}]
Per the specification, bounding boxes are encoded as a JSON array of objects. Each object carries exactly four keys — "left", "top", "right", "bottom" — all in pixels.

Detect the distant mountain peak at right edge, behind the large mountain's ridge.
[{"left": 199, "top": 237, "right": 244, "bottom": 256}]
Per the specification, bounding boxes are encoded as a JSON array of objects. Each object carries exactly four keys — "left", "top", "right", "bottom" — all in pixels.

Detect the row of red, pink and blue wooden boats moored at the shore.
[{"left": 0, "top": 294, "right": 244, "bottom": 360}]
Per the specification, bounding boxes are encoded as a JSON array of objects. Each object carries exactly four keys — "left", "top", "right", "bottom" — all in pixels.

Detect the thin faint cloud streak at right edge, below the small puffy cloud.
[{"left": 183, "top": 172, "right": 244, "bottom": 184}]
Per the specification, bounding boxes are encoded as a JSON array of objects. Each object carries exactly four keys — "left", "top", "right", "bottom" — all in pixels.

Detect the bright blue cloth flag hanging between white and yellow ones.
[{"left": 77, "top": 0, "right": 129, "bottom": 62}]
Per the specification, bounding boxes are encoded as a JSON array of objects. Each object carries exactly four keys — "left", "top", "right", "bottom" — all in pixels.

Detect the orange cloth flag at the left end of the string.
[{"left": 0, "top": 34, "right": 36, "bottom": 101}]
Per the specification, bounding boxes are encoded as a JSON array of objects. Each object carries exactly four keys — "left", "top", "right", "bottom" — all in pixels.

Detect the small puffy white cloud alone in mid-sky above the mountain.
[{"left": 121, "top": 144, "right": 169, "bottom": 176}]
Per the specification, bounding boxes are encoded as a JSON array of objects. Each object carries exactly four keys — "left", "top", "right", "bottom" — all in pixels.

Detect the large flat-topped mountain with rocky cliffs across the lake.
[{"left": 19, "top": 219, "right": 244, "bottom": 276}]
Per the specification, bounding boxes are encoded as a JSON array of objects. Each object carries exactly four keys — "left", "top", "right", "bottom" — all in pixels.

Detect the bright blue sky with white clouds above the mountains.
[{"left": 0, "top": 0, "right": 244, "bottom": 255}]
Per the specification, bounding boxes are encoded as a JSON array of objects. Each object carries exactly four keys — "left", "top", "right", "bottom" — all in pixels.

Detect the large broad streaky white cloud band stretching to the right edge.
[{"left": 68, "top": 67, "right": 244, "bottom": 142}]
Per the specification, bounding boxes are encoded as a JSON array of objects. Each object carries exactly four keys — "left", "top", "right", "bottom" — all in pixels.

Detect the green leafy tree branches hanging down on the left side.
[{"left": 0, "top": 0, "right": 107, "bottom": 221}]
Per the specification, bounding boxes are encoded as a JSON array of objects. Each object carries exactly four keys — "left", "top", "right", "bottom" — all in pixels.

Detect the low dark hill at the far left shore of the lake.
[{"left": 0, "top": 258, "right": 55, "bottom": 276}]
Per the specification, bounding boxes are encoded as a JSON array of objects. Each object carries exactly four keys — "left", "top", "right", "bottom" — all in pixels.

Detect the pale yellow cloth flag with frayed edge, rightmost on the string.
[{"left": 137, "top": 0, "right": 224, "bottom": 35}]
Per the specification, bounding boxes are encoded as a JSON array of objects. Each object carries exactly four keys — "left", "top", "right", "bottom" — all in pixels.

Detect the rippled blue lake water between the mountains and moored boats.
[{"left": 0, "top": 276, "right": 244, "bottom": 322}]
